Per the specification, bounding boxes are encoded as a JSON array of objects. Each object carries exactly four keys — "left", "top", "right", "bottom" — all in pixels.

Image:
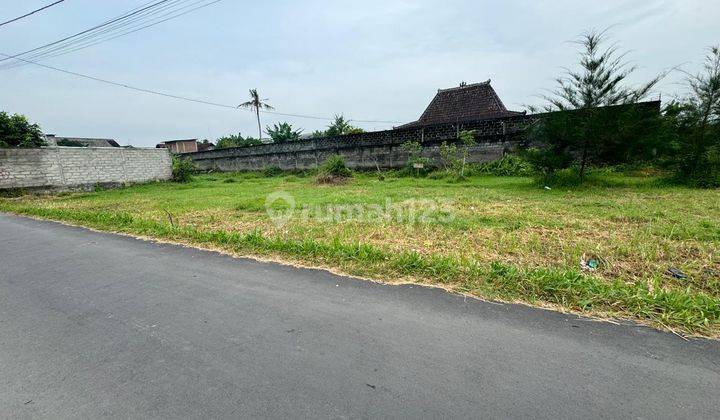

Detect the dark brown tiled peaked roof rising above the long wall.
[{"left": 397, "top": 80, "right": 524, "bottom": 128}]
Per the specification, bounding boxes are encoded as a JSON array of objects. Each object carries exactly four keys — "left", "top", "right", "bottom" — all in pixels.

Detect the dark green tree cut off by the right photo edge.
[{"left": 665, "top": 46, "right": 720, "bottom": 187}]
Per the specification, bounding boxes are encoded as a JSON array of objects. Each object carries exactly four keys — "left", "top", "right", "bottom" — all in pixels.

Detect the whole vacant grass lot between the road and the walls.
[{"left": 0, "top": 173, "right": 720, "bottom": 337}]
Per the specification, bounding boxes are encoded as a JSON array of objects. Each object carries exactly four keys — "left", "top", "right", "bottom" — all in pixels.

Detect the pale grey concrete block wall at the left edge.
[{"left": 0, "top": 147, "right": 172, "bottom": 190}]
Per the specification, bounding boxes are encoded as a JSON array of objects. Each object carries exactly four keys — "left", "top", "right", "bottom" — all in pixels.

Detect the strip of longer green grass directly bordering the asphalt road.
[{"left": 0, "top": 200, "right": 720, "bottom": 337}]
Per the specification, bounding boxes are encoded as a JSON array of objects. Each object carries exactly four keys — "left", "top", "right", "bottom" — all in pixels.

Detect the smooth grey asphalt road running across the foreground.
[{"left": 0, "top": 214, "right": 720, "bottom": 419}]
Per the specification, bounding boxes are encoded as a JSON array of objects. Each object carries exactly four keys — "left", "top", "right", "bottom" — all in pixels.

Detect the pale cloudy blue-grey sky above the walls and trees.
[{"left": 0, "top": 0, "right": 720, "bottom": 146}]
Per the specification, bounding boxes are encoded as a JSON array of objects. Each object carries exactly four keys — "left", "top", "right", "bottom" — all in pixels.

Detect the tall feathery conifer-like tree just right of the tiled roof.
[{"left": 527, "top": 31, "right": 663, "bottom": 182}]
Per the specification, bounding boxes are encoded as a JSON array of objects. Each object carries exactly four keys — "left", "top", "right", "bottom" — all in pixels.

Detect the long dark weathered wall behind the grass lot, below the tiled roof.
[{"left": 182, "top": 115, "right": 534, "bottom": 171}]
